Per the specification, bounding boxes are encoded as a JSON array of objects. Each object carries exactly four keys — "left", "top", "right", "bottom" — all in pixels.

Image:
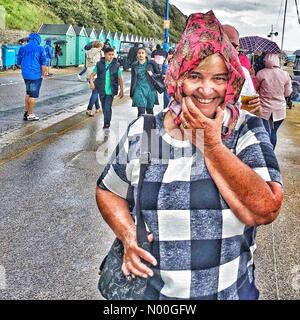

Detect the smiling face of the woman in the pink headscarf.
[{"left": 182, "top": 54, "right": 228, "bottom": 118}]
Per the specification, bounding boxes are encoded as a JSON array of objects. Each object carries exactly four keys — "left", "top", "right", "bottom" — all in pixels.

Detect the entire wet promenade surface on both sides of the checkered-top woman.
[{"left": 0, "top": 96, "right": 300, "bottom": 299}]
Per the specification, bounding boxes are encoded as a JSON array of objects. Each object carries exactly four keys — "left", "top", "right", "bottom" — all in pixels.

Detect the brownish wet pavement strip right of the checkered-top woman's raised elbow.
[{"left": 255, "top": 104, "right": 300, "bottom": 300}]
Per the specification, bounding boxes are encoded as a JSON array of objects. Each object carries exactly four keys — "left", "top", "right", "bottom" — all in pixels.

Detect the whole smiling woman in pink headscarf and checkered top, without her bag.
[{"left": 96, "top": 11, "right": 282, "bottom": 300}]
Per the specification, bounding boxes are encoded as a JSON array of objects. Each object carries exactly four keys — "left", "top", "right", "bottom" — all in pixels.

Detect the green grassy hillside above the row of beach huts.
[{"left": 0, "top": 0, "right": 185, "bottom": 42}]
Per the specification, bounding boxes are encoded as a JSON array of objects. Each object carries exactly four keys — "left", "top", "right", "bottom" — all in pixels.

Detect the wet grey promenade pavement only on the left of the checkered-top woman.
[{"left": 0, "top": 98, "right": 143, "bottom": 299}]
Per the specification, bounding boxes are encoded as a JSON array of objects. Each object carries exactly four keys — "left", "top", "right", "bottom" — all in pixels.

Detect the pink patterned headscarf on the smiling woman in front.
[{"left": 165, "top": 11, "right": 245, "bottom": 136}]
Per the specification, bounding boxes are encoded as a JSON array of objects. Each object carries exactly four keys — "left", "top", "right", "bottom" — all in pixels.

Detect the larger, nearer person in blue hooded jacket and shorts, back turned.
[{"left": 17, "top": 32, "right": 47, "bottom": 121}]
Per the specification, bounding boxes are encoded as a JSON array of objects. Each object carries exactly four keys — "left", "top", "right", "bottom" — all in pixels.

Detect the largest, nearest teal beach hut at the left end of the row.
[{"left": 38, "top": 24, "right": 76, "bottom": 67}]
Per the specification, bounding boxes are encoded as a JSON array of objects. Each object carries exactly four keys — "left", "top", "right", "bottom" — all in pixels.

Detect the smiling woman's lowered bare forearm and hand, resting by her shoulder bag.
[{"left": 96, "top": 187, "right": 157, "bottom": 278}]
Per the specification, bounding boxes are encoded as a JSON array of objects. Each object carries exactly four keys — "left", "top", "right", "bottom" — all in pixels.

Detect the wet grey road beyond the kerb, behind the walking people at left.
[{"left": 0, "top": 68, "right": 130, "bottom": 136}]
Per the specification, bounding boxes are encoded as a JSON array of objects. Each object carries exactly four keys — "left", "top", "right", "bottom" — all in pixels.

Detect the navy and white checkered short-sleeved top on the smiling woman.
[{"left": 98, "top": 110, "right": 281, "bottom": 300}]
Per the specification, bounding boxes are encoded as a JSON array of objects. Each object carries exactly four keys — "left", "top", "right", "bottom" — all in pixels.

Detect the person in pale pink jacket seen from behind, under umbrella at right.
[{"left": 256, "top": 53, "right": 293, "bottom": 149}]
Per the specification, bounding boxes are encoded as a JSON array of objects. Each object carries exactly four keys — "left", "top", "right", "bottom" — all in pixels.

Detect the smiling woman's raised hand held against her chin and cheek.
[{"left": 180, "top": 97, "right": 224, "bottom": 152}]
